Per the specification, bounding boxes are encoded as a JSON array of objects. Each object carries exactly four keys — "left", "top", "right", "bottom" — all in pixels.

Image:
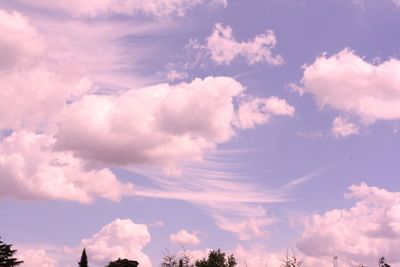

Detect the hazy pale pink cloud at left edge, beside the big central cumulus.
[{"left": 0, "top": 67, "right": 92, "bottom": 130}]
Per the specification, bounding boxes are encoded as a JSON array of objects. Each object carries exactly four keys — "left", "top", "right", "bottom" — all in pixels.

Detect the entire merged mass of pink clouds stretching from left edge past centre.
[{"left": 0, "top": 7, "right": 294, "bottom": 203}]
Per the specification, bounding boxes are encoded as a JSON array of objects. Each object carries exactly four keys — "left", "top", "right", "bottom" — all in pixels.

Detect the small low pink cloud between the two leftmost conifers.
[{"left": 18, "top": 248, "right": 57, "bottom": 267}]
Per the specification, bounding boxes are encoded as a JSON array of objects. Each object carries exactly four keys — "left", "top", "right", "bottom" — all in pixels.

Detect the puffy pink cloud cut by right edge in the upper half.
[{"left": 302, "top": 49, "right": 400, "bottom": 123}]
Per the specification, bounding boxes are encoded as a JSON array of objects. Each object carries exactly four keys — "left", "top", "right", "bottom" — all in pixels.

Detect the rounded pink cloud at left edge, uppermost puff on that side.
[{"left": 0, "top": 9, "right": 45, "bottom": 71}]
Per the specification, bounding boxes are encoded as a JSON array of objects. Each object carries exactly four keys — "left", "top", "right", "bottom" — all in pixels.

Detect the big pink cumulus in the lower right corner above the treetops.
[{"left": 297, "top": 184, "right": 400, "bottom": 266}]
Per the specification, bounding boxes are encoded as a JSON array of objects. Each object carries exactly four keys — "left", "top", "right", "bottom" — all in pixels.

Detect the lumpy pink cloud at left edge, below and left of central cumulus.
[{"left": 0, "top": 131, "right": 133, "bottom": 203}]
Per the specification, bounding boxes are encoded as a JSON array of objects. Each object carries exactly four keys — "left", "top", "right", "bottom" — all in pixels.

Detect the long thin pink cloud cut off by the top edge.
[{"left": 18, "top": 0, "right": 227, "bottom": 17}]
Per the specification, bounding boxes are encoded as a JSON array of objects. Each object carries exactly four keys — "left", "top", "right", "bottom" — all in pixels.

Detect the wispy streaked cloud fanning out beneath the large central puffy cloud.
[{"left": 133, "top": 151, "right": 288, "bottom": 240}]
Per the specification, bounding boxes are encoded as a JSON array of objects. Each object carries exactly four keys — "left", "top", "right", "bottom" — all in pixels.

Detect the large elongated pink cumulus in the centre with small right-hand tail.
[{"left": 56, "top": 77, "right": 293, "bottom": 173}]
